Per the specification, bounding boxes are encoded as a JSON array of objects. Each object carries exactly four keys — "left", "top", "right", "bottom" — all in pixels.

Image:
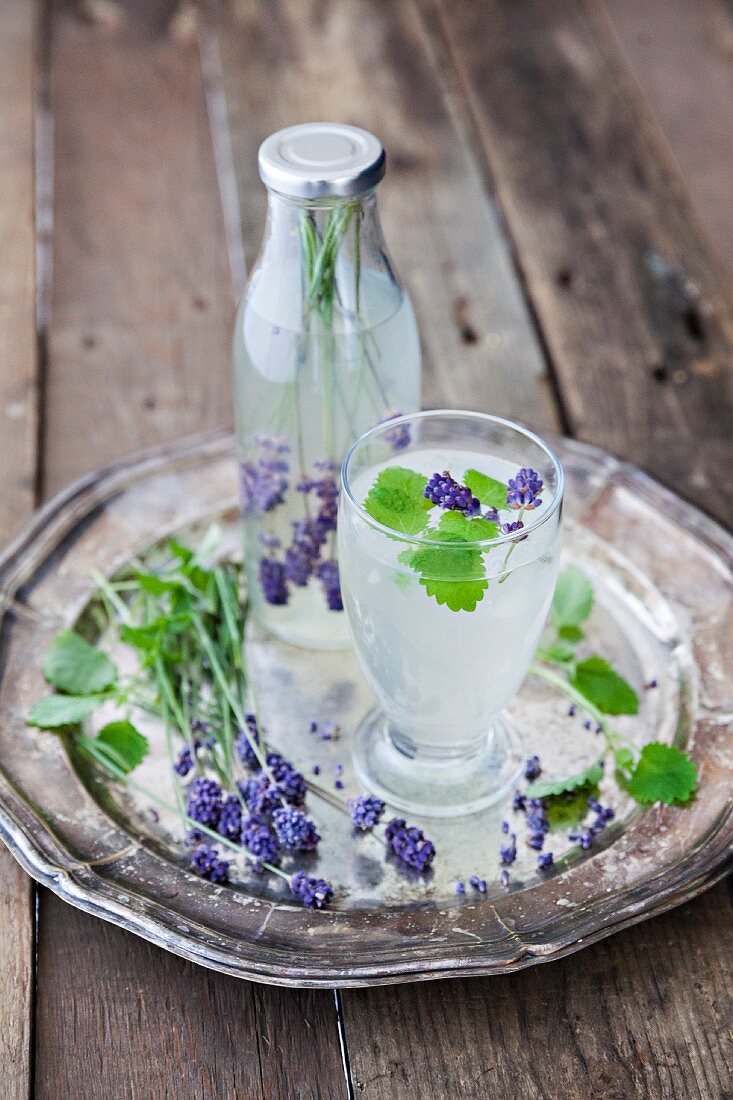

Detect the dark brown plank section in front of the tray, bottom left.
[{"left": 35, "top": 891, "right": 346, "bottom": 1100}]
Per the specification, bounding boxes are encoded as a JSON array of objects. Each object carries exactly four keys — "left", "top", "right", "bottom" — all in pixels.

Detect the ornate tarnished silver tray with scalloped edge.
[{"left": 0, "top": 435, "right": 733, "bottom": 986}]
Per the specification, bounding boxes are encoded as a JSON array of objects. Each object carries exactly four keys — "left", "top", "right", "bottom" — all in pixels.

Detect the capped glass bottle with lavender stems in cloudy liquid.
[{"left": 233, "top": 123, "right": 420, "bottom": 649}]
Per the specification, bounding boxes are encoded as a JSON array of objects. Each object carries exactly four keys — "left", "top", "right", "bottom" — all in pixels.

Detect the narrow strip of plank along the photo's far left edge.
[{"left": 0, "top": 0, "right": 37, "bottom": 1100}]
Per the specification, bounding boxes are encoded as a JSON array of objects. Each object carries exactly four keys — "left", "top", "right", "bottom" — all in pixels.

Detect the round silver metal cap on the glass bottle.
[{"left": 258, "top": 122, "right": 384, "bottom": 199}]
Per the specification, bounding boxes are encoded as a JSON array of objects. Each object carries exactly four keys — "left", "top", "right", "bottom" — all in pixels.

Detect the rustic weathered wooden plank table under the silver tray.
[{"left": 0, "top": 0, "right": 733, "bottom": 1100}]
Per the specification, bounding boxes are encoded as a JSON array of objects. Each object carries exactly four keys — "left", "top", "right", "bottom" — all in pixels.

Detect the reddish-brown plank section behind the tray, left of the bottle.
[{"left": 43, "top": 0, "right": 233, "bottom": 493}]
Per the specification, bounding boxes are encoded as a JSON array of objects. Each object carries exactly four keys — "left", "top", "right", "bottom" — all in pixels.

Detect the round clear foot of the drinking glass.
[{"left": 351, "top": 708, "right": 524, "bottom": 817}]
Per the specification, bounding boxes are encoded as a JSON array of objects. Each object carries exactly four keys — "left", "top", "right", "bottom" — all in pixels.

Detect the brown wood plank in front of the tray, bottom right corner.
[{"left": 347, "top": 886, "right": 733, "bottom": 1100}]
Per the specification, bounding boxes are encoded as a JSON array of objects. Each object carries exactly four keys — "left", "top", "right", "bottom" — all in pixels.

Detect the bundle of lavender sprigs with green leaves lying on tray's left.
[{"left": 29, "top": 541, "right": 435, "bottom": 909}]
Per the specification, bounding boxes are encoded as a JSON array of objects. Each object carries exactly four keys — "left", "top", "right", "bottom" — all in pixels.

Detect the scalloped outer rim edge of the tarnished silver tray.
[{"left": 0, "top": 429, "right": 733, "bottom": 988}]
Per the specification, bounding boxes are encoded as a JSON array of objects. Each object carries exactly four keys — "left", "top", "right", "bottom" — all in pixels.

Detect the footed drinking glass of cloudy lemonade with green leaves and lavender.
[{"left": 338, "top": 410, "right": 564, "bottom": 816}]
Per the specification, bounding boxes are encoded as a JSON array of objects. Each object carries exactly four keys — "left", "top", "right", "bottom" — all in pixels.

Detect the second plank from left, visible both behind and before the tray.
[{"left": 35, "top": 0, "right": 344, "bottom": 1100}]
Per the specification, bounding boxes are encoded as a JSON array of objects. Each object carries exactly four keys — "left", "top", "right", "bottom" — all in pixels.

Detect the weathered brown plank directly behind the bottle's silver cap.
[{"left": 214, "top": 0, "right": 557, "bottom": 428}]
